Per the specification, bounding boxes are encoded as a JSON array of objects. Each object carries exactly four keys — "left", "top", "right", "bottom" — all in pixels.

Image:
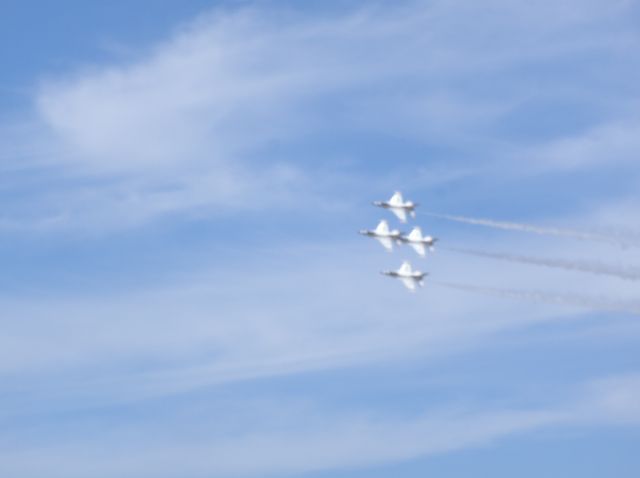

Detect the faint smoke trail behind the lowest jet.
[{"left": 430, "top": 280, "right": 640, "bottom": 315}]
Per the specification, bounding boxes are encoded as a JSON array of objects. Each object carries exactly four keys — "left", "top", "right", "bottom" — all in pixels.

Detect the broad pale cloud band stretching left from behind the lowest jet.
[{"left": 0, "top": 228, "right": 637, "bottom": 413}]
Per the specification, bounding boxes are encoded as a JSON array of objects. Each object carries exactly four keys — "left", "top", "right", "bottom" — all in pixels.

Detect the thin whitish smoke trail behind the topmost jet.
[{"left": 423, "top": 212, "right": 638, "bottom": 247}]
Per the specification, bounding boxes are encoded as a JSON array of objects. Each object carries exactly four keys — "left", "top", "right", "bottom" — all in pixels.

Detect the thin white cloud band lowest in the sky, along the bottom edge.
[{"left": 0, "top": 374, "right": 640, "bottom": 477}]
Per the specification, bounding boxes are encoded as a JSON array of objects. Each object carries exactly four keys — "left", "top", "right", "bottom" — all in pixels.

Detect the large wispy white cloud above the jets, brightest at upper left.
[{"left": 2, "top": 1, "right": 629, "bottom": 228}]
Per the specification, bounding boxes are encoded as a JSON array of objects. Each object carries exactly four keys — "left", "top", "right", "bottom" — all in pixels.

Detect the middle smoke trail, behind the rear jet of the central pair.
[{"left": 440, "top": 247, "right": 640, "bottom": 281}]
